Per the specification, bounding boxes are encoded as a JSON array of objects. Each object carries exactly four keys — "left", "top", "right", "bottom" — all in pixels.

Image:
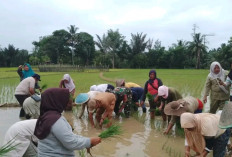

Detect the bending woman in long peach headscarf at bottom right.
[{"left": 180, "top": 112, "right": 230, "bottom": 157}]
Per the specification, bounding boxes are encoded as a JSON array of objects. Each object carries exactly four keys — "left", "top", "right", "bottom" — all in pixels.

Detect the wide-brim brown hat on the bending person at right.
[{"left": 164, "top": 100, "right": 187, "bottom": 116}]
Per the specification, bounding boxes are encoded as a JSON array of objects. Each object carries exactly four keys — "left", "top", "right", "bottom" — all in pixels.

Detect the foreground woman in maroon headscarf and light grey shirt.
[{"left": 34, "top": 88, "right": 101, "bottom": 157}]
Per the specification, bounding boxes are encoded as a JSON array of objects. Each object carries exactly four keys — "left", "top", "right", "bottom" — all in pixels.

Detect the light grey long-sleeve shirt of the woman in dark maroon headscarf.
[{"left": 38, "top": 116, "right": 91, "bottom": 157}]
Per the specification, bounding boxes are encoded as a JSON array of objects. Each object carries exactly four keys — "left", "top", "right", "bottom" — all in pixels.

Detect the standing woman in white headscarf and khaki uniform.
[{"left": 203, "top": 62, "right": 230, "bottom": 113}]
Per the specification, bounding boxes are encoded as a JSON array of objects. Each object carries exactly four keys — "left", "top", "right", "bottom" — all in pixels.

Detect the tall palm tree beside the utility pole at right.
[{"left": 188, "top": 33, "right": 207, "bottom": 69}]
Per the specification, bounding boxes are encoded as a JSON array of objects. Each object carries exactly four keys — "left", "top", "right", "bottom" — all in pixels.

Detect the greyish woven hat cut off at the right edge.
[{"left": 219, "top": 102, "right": 232, "bottom": 129}]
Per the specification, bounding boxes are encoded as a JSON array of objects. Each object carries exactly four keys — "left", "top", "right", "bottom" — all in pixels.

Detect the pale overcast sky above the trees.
[{"left": 0, "top": 0, "right": 232, "bottom": 51}]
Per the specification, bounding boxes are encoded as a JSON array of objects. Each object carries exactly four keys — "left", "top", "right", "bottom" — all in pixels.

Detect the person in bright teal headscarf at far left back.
[{"left": 17, "top": 63, "right": 35, "bottom": 81}]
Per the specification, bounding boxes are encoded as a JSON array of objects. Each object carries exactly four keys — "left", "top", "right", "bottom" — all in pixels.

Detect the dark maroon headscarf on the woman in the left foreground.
[{"left": 34, "top": 88, "right": 69, "bottom": 140}]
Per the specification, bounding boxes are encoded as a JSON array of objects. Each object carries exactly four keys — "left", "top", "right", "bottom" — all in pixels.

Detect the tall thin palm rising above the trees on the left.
[{"left": 68, "top": 25, "right": 79, "bottom": 65}]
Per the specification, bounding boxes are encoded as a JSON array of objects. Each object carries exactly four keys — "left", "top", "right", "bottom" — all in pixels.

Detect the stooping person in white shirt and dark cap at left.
[{"left": 15, "top": 74, "right": 41, "bottom": 117}]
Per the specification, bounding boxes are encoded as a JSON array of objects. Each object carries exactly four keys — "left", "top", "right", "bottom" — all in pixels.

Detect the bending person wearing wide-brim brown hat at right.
[{"left": 164, "top": 96, "right": 203, "bottom": 134}]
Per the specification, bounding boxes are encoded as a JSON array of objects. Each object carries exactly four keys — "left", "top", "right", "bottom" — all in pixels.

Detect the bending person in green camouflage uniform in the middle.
[{"left": 112, "top": 87, "right": 132, "bottom": 118}]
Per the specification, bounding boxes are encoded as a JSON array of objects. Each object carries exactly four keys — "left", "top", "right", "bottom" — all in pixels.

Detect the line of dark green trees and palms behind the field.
[{"left": 0, "top": 25, "right": 232, "bottom": 69}]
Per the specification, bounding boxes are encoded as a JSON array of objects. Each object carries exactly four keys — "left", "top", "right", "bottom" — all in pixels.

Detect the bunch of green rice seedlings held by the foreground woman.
[{"left": 98, "top": 125, "right": 122, "bottom": 138}]
